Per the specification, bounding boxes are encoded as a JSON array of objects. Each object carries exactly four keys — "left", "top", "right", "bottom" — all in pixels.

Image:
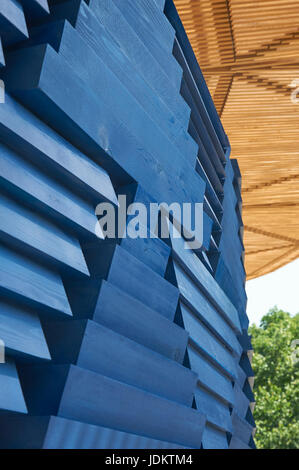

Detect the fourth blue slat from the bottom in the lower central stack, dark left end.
[{"left": 64, "top": 278, "right": 188, "bottom": 362}]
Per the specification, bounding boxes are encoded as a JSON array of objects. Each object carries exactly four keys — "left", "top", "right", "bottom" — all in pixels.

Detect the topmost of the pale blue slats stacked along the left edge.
[{"left": 0, "top": 93, "right": 117, "bottom": 204}]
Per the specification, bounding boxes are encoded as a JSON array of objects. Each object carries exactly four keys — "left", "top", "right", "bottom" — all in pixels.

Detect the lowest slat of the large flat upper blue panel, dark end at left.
[{"left": 7, "top": 46, "right": 205, "bottom": 209}]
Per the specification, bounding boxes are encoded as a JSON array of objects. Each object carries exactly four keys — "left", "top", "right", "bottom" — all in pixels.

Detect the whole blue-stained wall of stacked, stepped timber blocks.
[{"left": 0, "top": 0, "right": 255, "bottom": 449}]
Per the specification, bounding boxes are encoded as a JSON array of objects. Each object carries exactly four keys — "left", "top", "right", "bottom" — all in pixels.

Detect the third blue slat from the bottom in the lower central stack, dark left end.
[{"left": 44, "top": 320, "right": 197, "bottom": 406}]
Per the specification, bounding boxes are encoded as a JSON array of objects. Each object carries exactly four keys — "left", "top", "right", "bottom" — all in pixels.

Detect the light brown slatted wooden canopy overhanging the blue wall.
[{"left": 175, "top": 0, "right": 299, "bottom": 279}]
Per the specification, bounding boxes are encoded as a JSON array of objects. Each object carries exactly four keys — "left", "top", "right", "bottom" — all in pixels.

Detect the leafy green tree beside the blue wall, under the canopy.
[{"left": 249, "top": 307, "right": 299, "bottom": 449}]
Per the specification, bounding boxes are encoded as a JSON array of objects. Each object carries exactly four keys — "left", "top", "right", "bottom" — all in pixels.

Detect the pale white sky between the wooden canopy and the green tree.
[{"left": 246, "top": 258, "right": 299, "bottom": 325}]
